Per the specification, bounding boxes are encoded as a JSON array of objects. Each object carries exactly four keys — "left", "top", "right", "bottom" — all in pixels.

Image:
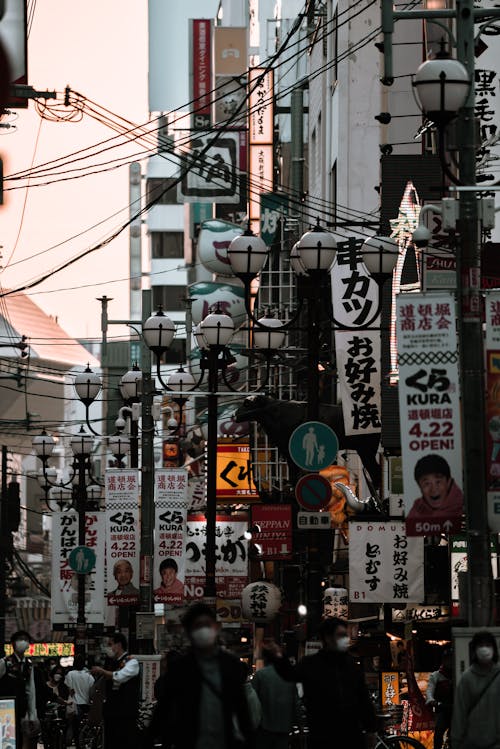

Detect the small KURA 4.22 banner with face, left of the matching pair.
[{"left": 105, "top": 468, "right": 140, "bottom": 606}]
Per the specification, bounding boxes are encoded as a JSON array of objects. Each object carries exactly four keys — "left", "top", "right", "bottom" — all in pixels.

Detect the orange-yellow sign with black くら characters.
[{"left": 215, "top": 441, "right": 259, "bottom": 504}]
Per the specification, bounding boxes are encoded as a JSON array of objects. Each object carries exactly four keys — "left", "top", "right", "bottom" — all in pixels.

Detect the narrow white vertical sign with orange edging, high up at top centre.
[{"left": 248, "top": 68, "right": 274, "bottom": 232}]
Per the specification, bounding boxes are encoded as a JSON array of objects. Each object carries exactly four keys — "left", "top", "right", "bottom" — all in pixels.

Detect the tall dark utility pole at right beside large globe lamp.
[{"left": 382, "top": 0, "right": 500, "bottom": 627}]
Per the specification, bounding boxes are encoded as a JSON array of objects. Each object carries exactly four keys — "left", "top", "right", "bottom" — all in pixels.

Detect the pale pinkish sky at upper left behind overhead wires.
[{"left": 0, "top": 0, "right": 148, "bottom": 337}]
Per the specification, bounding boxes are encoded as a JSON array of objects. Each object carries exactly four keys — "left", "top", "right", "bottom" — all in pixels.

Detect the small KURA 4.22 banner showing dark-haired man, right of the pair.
[{"left": 153, "top": 468, "right": 188, "bottom": 605}]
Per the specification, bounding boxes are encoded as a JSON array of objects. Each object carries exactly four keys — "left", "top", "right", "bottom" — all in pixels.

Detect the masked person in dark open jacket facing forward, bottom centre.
[{"left": 158, "top": 603, "right": 253, "bottom": 749}]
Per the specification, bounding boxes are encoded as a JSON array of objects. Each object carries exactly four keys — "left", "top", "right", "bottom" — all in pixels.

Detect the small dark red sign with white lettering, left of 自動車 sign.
[{"left": 252, "top": 505, "right": 292, "bottom": 560}]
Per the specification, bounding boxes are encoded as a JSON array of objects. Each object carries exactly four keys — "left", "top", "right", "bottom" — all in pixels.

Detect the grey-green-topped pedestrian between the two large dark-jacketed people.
[{"left": 251, "top": 652, "right": 298, "bottom": 749}]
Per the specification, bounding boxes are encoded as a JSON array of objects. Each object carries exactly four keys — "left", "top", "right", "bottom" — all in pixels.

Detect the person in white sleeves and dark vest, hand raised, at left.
[{"left": 92, "top": 632, "right": 140, "bottom": 749}]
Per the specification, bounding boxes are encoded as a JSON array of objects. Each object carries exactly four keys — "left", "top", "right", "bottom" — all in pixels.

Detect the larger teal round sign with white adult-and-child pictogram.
[{"left": 288, "top": 421, "right": 339, "bottom": 471}]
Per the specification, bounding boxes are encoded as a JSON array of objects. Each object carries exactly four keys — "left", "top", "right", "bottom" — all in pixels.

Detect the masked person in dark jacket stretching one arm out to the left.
[{"left": 267, "top": 617, "right": 377, "bottom": 749}]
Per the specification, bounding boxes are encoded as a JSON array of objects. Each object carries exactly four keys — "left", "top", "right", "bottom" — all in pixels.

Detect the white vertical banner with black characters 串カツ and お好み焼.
[{"left": 332, "top": 238, "right": 381, "bottom": 435}]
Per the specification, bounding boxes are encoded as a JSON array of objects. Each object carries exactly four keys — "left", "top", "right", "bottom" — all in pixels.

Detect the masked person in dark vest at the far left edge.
[{"left": 0, "top": 630, "right": 40, "bottom": 749}]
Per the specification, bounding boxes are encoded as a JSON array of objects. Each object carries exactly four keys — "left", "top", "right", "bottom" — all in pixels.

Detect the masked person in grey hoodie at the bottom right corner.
[{"left": 451, "top": 630, "right": 500, "bottom": 749}]
